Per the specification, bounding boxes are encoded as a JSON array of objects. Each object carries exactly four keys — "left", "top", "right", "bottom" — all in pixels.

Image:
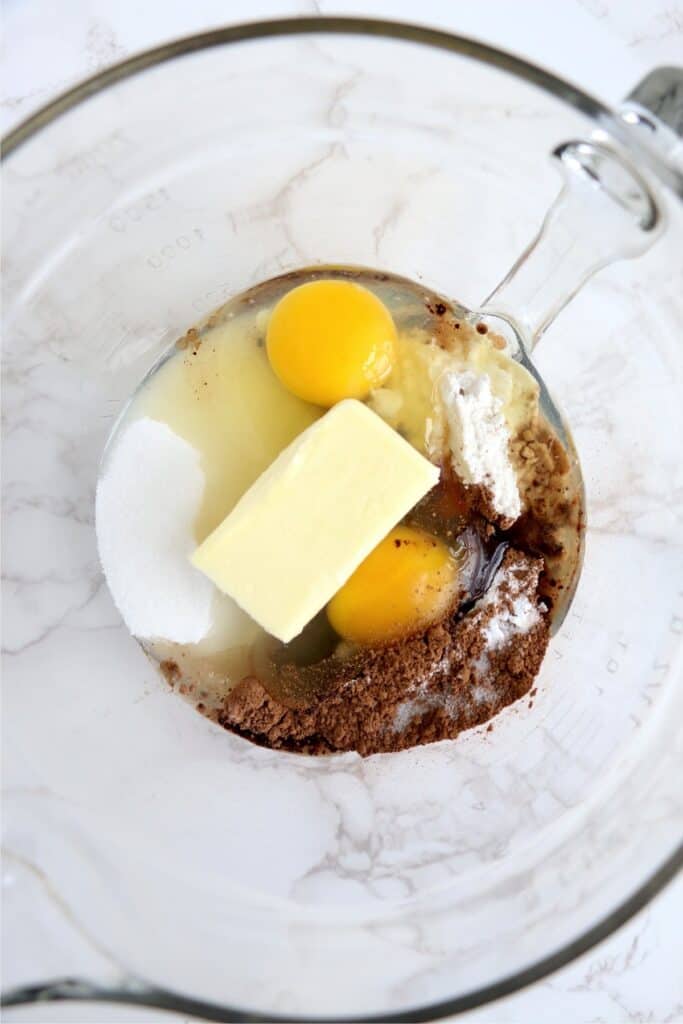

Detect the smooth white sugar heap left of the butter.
[{"left": 95, "top": 418, "right": 215, "bottom": 643}]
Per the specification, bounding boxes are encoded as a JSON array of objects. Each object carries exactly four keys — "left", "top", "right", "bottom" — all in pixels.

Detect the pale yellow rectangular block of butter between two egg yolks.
[{"left": 191, "top": 399, "right": 439, "bottom": 643}]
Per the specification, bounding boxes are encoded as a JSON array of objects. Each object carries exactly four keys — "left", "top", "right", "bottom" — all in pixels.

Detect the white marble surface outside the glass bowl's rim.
[{"left": 2, "top": 0, "right": 683, "bottom": 1024}]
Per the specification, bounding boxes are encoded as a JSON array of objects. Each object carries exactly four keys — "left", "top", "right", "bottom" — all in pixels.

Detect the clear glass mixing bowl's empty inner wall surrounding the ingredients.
[{"left": 3, "top": 18, "right": 683, "bottom": 1020}]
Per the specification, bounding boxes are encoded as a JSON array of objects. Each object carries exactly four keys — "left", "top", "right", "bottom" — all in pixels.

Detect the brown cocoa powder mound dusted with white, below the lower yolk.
[{"left": 218, "top": 550, "right": 549, "bottom": 755}]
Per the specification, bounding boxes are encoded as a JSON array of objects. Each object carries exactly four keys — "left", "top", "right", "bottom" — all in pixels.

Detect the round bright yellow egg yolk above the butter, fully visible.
[{"left": 266, "top": 281, "right": 396, "bottom": 407}]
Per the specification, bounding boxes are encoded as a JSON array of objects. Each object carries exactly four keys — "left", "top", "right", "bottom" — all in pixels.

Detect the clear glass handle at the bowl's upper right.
[{"left": 481, "top": 69, "right": 683, "bottom": 349}]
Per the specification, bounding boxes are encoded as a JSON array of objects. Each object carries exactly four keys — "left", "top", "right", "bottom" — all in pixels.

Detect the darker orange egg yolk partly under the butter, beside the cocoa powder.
[{"left": 328, "top": 526, "right": 458, "bottom": 644}]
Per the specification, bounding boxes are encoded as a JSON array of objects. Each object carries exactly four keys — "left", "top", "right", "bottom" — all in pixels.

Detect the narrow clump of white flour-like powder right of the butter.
[{"left": 438, "top": 370, "right": 521, "bottom": 520}]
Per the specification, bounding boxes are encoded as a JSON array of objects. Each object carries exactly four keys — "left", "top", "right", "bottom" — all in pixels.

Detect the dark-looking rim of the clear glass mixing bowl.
[{"left": 0, "top": 15, "right": 683, "bottom": 1024}]
